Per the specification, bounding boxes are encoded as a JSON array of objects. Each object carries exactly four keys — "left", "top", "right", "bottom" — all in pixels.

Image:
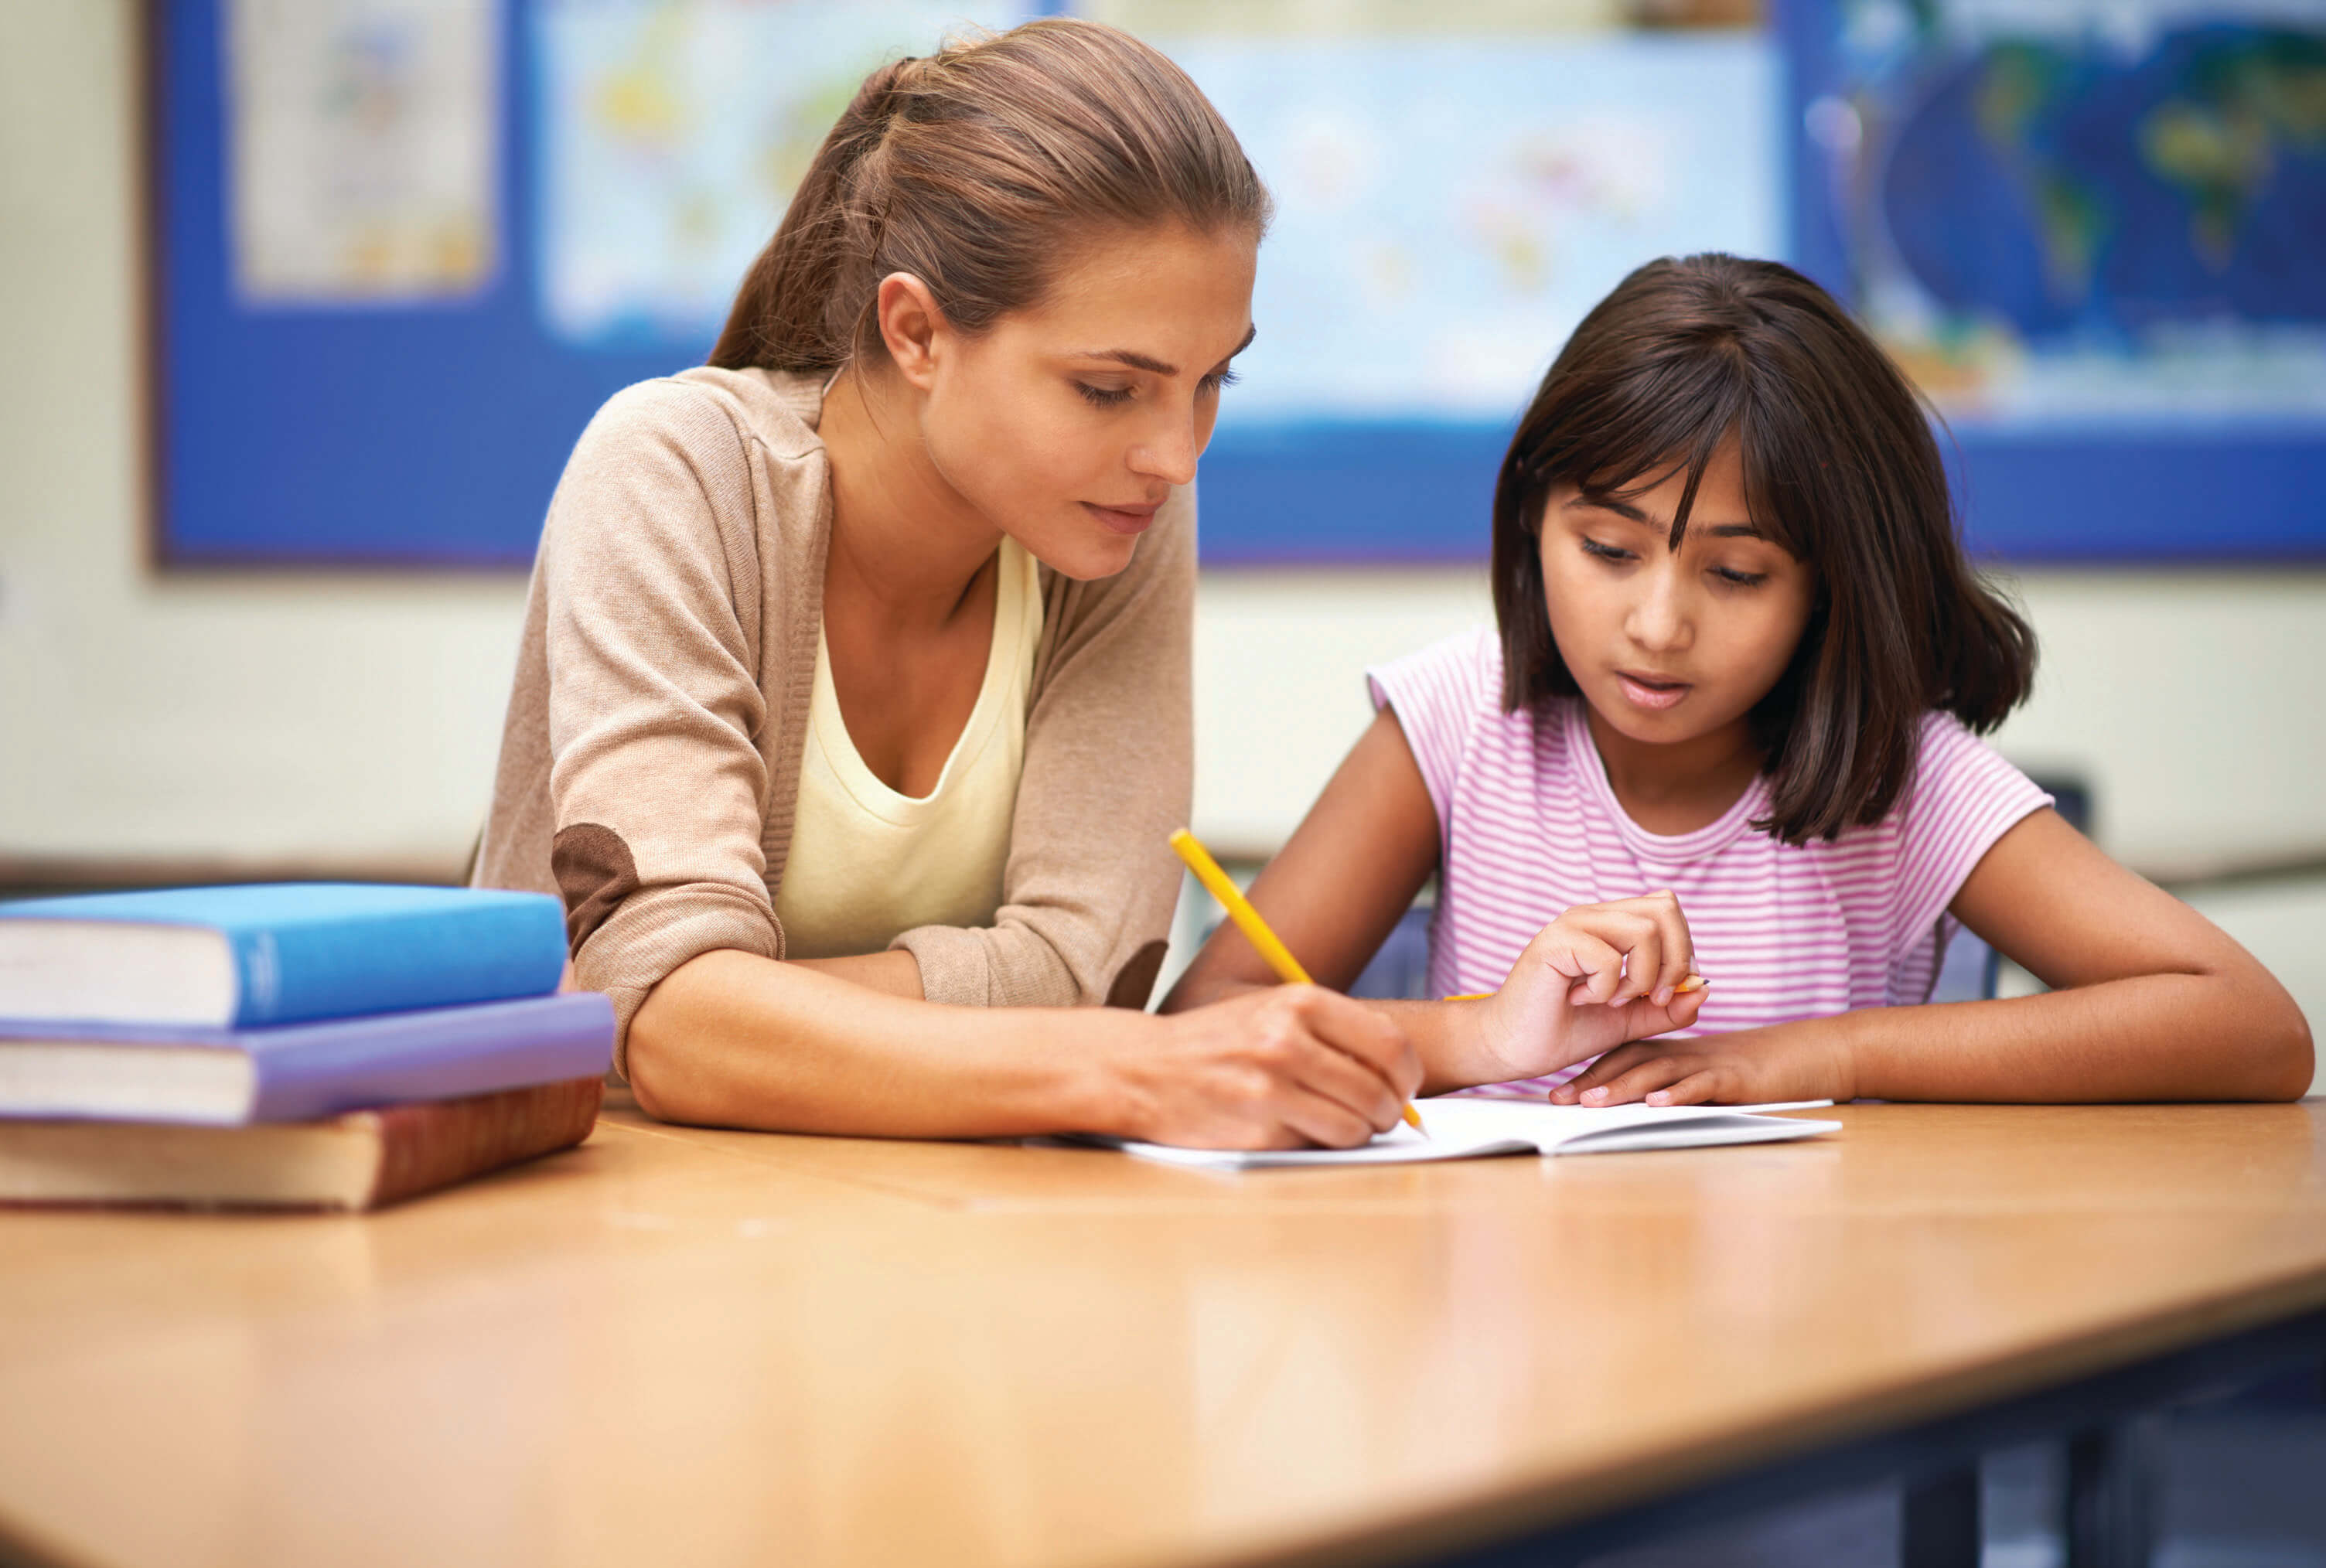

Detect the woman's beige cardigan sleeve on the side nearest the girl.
[{"left": 891, "top": 489, "right": 1195, "bottom": 1007}]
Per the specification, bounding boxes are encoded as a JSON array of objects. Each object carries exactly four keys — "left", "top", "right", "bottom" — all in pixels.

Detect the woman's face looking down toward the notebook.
[{"left": 921, "top": 226, "right": 1258, "bottom": 579}]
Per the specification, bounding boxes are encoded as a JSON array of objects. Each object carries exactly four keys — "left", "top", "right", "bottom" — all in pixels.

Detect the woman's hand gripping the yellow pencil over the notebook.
[{"left": 1100, "top": 987, "right": 1421, "bottom": 1149}]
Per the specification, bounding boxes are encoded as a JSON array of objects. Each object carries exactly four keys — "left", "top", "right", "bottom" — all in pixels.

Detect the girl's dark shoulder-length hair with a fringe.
[{"left": 1493, "top": 256, "right": 2035, "bottom": 844}]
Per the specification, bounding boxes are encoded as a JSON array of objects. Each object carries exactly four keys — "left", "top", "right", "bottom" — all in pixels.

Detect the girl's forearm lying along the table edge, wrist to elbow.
[{"left": 1833, "top": 966, "right": 2312, "bottom": 1103}]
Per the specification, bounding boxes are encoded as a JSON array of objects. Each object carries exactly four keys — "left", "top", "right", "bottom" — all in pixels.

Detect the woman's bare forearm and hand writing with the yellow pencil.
[{"left": 628, "top": 949, "right": 1421, "bottom": 1149}]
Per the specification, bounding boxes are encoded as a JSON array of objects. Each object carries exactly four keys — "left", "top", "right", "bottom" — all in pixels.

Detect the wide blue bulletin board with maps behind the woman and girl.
[{"left": 149, "top": 0, "right": 2326, "bottom": 568}]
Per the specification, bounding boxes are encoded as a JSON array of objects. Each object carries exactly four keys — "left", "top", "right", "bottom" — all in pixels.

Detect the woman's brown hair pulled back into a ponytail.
[{"left": 709, "top": 16, "right": 1267, "bottom": 372}]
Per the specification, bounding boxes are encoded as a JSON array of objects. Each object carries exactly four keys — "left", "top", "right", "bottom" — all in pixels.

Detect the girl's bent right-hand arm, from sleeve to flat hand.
[{"left": 1551, "top": 810, "right": 2312, "bottom": 1105}]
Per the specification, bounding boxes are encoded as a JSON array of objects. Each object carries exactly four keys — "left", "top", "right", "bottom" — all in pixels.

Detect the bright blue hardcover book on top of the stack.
[{"left": 0, "top": 881, "right": 565, "bottom": 1028}]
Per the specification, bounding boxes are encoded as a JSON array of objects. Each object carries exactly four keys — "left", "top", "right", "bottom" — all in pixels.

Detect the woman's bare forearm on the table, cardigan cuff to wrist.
[{"left": 628, "top": 949, "right": 1120, "bottom": 1137}]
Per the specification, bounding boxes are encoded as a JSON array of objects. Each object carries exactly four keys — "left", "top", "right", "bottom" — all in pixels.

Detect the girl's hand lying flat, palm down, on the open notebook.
[{"left": 1551, "top": 1026, "right": 1856, "bottom": 1105}]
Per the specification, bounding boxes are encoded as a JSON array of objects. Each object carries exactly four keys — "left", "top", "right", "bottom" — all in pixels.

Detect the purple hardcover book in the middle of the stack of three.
[{"left": 0, "top": 991, "right": 614, "bottom": 1126}]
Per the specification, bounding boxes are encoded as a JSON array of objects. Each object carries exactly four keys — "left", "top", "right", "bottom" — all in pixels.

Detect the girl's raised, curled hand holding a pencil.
[{"left": 1475, "top": 893, "right": 1705, "bottom": 1082}]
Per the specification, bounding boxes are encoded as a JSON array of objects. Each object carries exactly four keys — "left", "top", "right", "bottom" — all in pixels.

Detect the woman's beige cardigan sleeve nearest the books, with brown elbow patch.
[{"left": 540, "top": 381, "right": 784, "bottom": 1070}]
